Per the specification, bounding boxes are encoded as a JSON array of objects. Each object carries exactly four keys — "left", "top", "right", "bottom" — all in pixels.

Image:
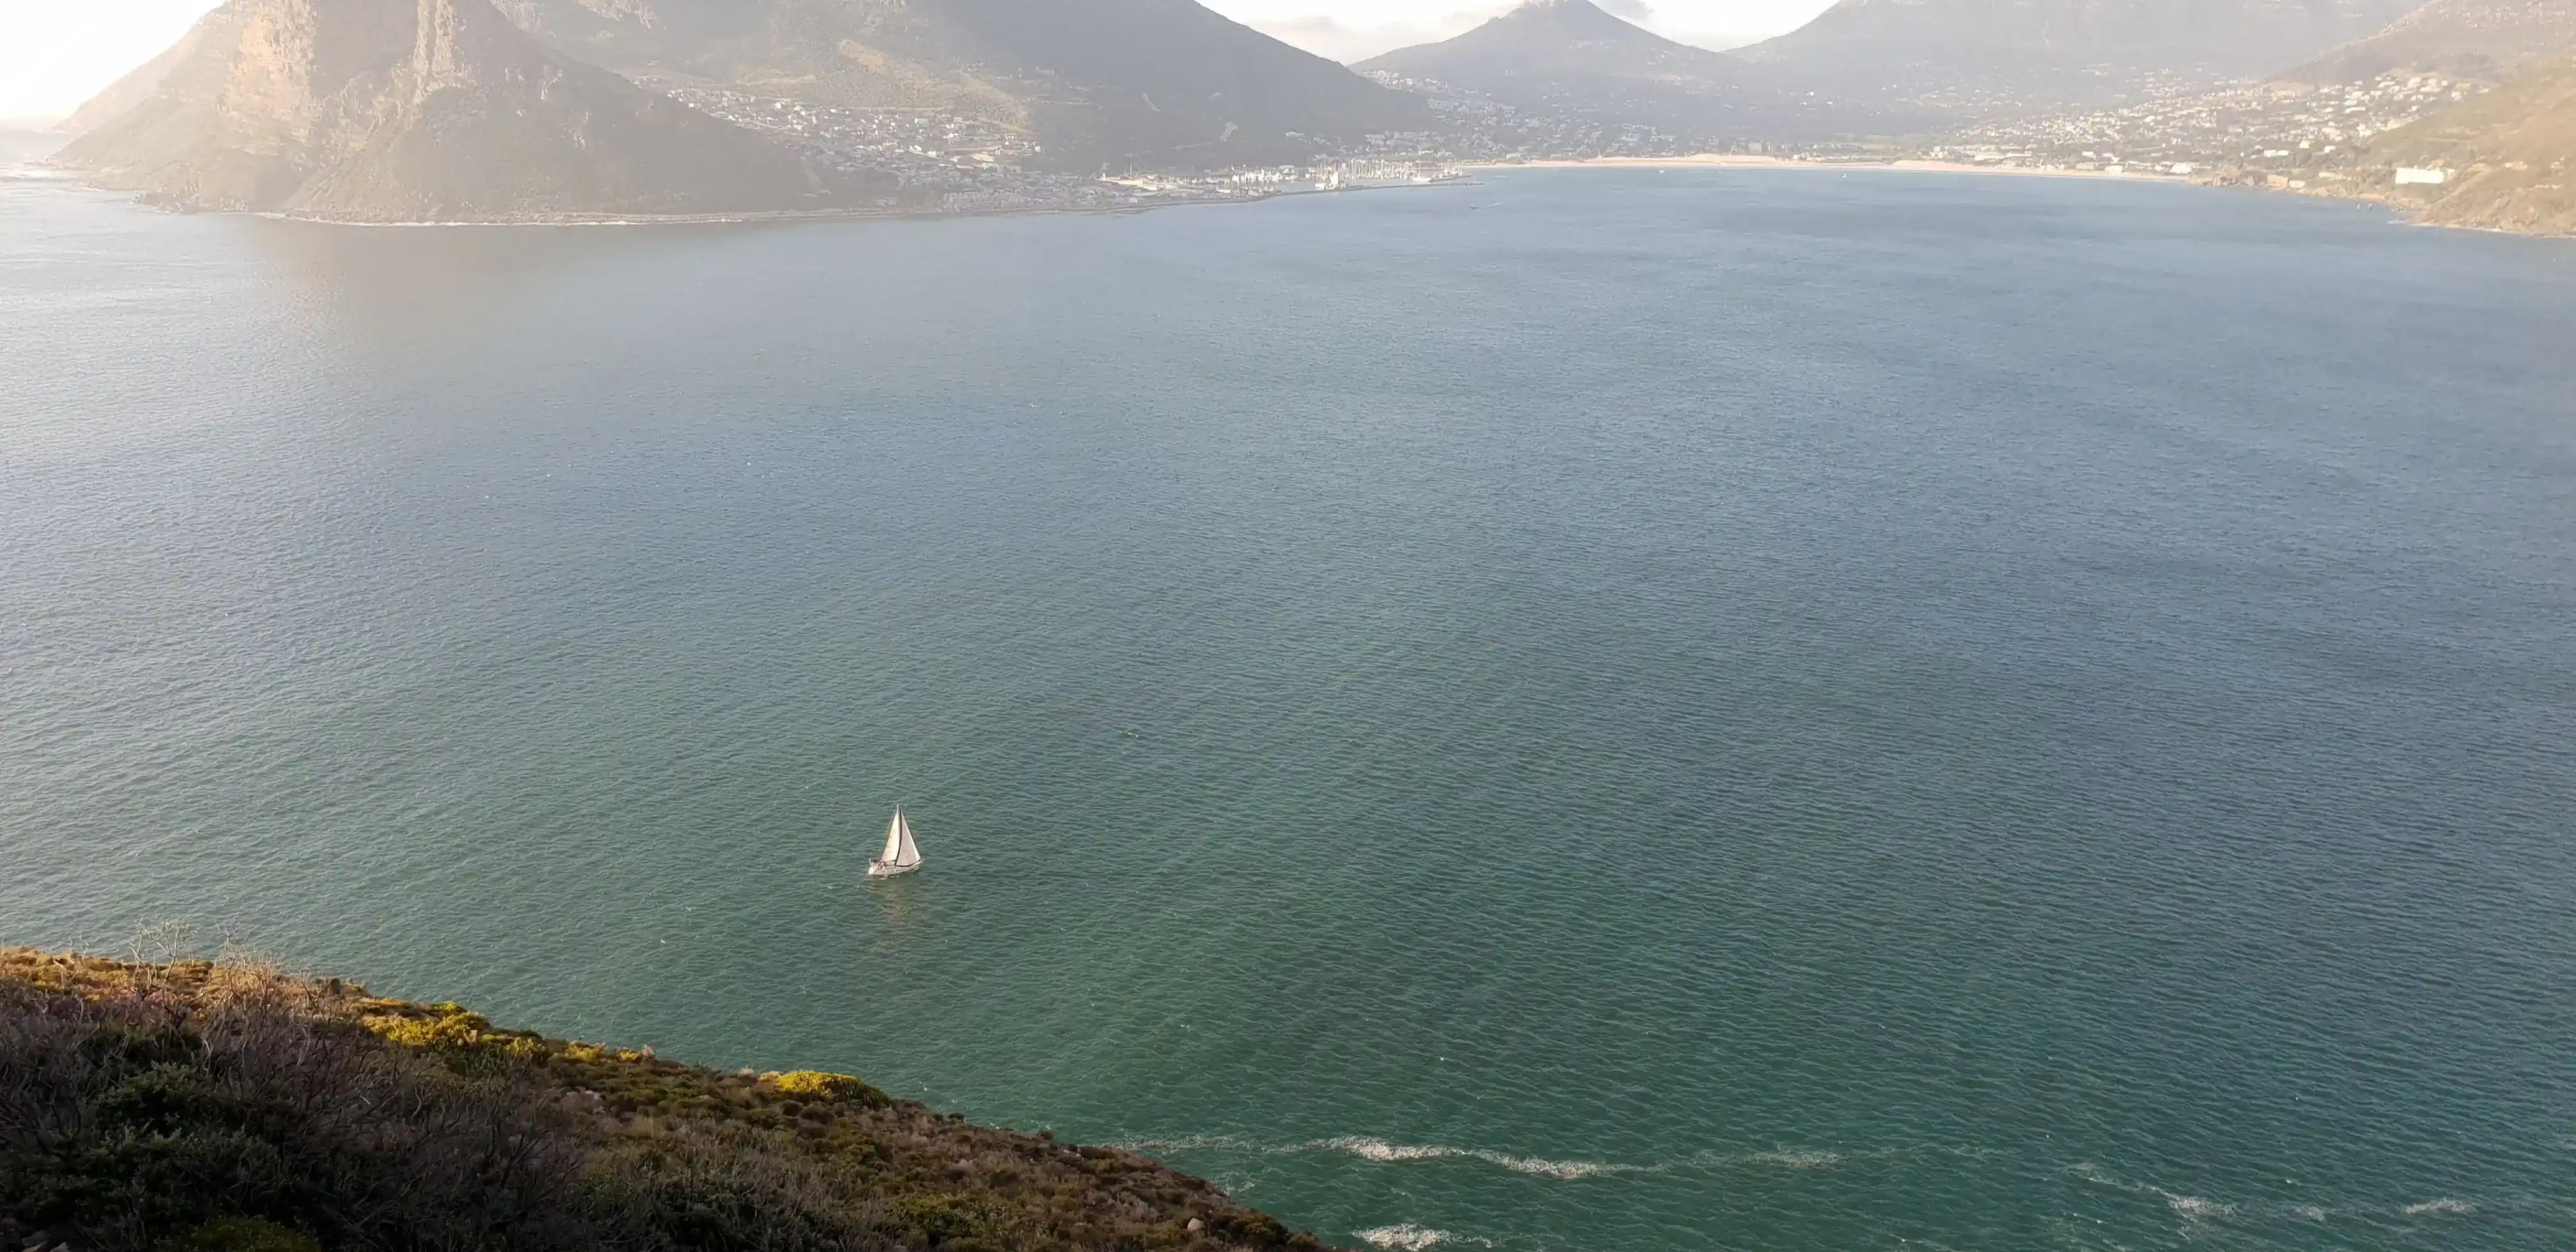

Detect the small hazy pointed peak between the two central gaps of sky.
[{"left": 1358, "top": 0, "right": 1770, "bottom": 137}]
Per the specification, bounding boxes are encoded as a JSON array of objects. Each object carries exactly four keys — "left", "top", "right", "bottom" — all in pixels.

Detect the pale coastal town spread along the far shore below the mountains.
[{"left": 654, "top": 57, "right": 2534, "bottom": 214}]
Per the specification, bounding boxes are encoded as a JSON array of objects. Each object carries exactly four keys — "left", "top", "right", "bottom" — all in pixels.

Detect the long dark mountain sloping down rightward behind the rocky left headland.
[{"left": 489, "top": 0, "right": 1430, "bottom": 170}]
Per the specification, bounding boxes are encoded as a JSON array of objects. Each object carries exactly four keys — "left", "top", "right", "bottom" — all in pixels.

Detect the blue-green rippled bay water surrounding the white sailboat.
[{"left": 0, "top": 153, "right": 2576, "bottom": 1252}]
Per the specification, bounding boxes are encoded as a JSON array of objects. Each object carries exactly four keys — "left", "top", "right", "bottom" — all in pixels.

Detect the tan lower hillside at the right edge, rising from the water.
[{"left": 2352, "top": 54, "right": 2576, "bottom": 234}]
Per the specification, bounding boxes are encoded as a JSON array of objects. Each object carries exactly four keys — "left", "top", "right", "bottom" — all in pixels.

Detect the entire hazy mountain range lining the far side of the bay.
[{"left": 50, "top": 0, "right": 2576, "bottom": 231}]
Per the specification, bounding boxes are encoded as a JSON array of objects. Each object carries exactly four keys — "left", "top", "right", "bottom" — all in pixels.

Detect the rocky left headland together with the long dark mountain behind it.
[{"left": 59, "top": 0, "right": 1430, "bottom": 222}]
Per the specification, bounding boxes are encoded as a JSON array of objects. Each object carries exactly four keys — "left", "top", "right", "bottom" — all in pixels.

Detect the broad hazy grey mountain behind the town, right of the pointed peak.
[{"left": 1742, "top": 0, "right": 2421, "bottom": 108}]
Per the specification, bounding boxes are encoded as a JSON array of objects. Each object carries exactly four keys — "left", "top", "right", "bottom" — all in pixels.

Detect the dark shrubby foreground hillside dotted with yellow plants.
[{"left": 0, "top": 950, "right": 1316, "bottom": 1252}]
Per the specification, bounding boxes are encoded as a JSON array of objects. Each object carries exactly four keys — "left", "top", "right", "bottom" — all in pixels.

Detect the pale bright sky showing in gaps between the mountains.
[{"left": 0, "top": 0, "right": 1832, "bottom": 119}]
